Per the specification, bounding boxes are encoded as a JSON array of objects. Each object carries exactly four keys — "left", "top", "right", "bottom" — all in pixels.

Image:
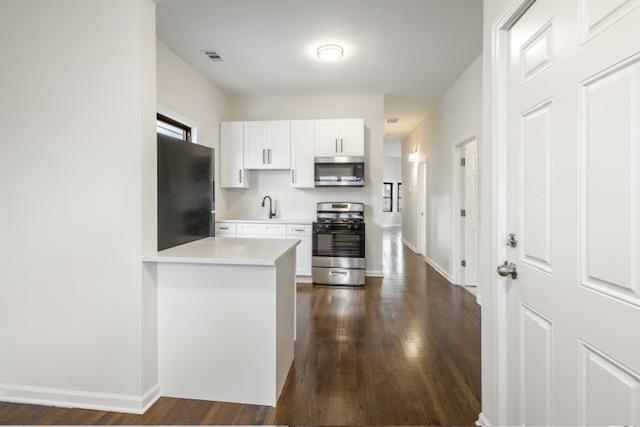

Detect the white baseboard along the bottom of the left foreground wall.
[{"left": 0, "top": 384, "right": 160, "bottom": 414}]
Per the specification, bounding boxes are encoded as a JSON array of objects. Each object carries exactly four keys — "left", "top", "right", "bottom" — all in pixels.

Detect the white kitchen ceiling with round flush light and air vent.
[{"left": 156, "top": 0, "right": 482, "bottom": 137}]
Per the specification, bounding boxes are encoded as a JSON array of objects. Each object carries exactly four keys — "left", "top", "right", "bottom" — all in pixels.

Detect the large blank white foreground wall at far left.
[{"left": 0, "top": 0, "right": 157, "bottom": 410}]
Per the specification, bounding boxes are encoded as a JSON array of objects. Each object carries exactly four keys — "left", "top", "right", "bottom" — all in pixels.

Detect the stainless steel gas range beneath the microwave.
[{"left": 312, "top": 202, "right": 365, "bottom": 286}]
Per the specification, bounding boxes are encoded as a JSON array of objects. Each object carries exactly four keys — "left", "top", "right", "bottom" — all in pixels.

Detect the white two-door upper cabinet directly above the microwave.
[{"left": 315, "top": 119, "right": 364, "bottom": 157}]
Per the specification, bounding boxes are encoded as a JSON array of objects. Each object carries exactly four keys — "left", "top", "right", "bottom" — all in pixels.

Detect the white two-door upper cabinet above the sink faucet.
[{"left": 244, "top": 120, "right": 291, "bottom": 169}]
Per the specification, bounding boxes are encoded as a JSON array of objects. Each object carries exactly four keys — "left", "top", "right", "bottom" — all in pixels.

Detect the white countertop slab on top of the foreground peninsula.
[{"left": 142, "top": 237, "right": 300, "bottom": 266}]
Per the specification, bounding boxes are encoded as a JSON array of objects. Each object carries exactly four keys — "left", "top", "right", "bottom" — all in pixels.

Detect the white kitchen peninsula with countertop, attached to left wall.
[{"left": 143, "top": 237, "right": 299, "bottom": 406}]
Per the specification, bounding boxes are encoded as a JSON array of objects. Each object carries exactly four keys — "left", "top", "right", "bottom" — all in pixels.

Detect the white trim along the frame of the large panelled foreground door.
[{"left": 488, "top": 0, "right": 536, "bottom": 424}]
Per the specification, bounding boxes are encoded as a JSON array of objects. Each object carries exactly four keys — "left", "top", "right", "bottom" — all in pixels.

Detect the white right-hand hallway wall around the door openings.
[{"left": 402, "top": 56, "right": 482, "bottom": 277}]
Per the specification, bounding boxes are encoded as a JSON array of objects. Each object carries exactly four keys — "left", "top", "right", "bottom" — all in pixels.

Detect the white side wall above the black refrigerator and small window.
[{"left": 157, "top": 39, "right": 229, "bottom": 217}]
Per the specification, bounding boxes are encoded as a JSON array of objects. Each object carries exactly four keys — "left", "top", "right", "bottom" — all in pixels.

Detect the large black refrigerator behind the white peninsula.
[{"left": 158, "top": 134, "right": 215, "bottom": 251}]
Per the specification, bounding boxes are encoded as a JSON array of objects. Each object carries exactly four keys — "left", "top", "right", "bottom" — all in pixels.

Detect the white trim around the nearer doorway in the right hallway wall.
[{"left": 451, "top": 134, "right": 478, "bottom": 285}]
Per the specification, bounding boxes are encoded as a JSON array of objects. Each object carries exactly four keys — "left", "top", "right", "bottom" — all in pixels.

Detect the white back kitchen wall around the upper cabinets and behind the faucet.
[{"left": 222, "top": 94, "right": 384, "bottom": 274}]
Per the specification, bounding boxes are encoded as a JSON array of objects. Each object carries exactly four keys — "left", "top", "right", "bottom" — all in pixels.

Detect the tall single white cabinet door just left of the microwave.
[{"left": 290, "top": 120, "right": 316, "bottom": 188}]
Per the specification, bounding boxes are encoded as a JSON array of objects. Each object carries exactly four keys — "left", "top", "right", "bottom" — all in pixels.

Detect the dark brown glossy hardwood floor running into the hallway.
[{"left": 0, "top": 229, "right": 480, "bottom": 425}]
